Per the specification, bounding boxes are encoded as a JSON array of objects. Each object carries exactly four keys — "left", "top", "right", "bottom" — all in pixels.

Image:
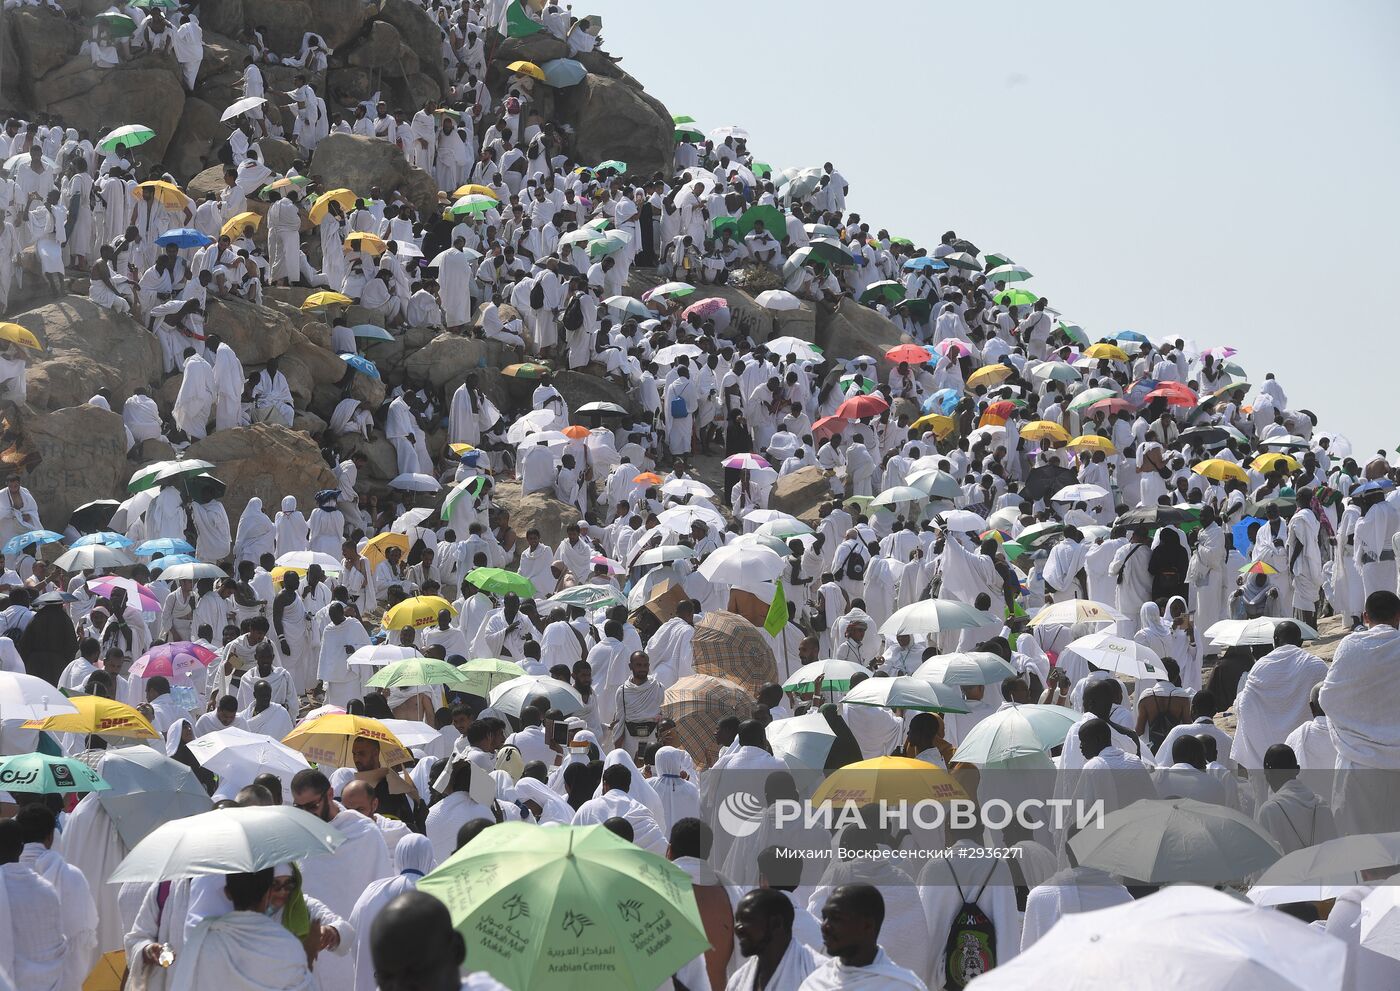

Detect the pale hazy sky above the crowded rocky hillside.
[{"left": 574, "top": 0, "right": 1400, "bottom": 455}]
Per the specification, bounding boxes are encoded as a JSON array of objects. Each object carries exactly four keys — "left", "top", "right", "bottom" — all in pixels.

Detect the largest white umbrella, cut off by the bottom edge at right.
[{"left": 972, "top": 885, "right": 1347, "bottom": 991}]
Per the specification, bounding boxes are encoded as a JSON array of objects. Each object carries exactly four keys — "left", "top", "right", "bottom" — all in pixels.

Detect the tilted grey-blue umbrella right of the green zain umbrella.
[{"left": 78, "top": 731, "right": 210, "bottom": 848}]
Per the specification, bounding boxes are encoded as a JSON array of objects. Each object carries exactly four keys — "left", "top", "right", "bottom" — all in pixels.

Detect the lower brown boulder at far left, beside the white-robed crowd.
[{"left": 18, "top": 405, "right": 132, "bottom": 530}]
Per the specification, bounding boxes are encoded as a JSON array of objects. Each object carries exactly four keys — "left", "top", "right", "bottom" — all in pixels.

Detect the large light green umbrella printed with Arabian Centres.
[{"left": 419, "top": 822, "right": 710, "bottom": 991}]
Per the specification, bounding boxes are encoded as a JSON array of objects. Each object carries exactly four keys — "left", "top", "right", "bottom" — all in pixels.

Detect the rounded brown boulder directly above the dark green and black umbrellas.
[{"left": 185, "top": 423, "right": 336, "bottom": 521}]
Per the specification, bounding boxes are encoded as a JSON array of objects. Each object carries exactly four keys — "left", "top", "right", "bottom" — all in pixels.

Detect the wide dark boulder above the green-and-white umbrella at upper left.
[{"left": 34, "top": 55, "right": 185, "bottom": 161}]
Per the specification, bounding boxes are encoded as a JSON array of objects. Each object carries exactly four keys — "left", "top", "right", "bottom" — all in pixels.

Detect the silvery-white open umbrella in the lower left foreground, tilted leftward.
[{"left": 108, "top": 805, "right": 344, "bottom": 882}]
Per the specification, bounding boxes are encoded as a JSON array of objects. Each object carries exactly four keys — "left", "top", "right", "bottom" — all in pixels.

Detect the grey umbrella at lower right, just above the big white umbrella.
[{"left": 1070, "top": 798, "right": 1282, "bottom": 885}]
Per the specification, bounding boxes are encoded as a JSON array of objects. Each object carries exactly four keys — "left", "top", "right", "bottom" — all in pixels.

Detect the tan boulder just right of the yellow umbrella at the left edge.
[{"left": 14, "top": 295, "right": 161, "bottom": 410}]
